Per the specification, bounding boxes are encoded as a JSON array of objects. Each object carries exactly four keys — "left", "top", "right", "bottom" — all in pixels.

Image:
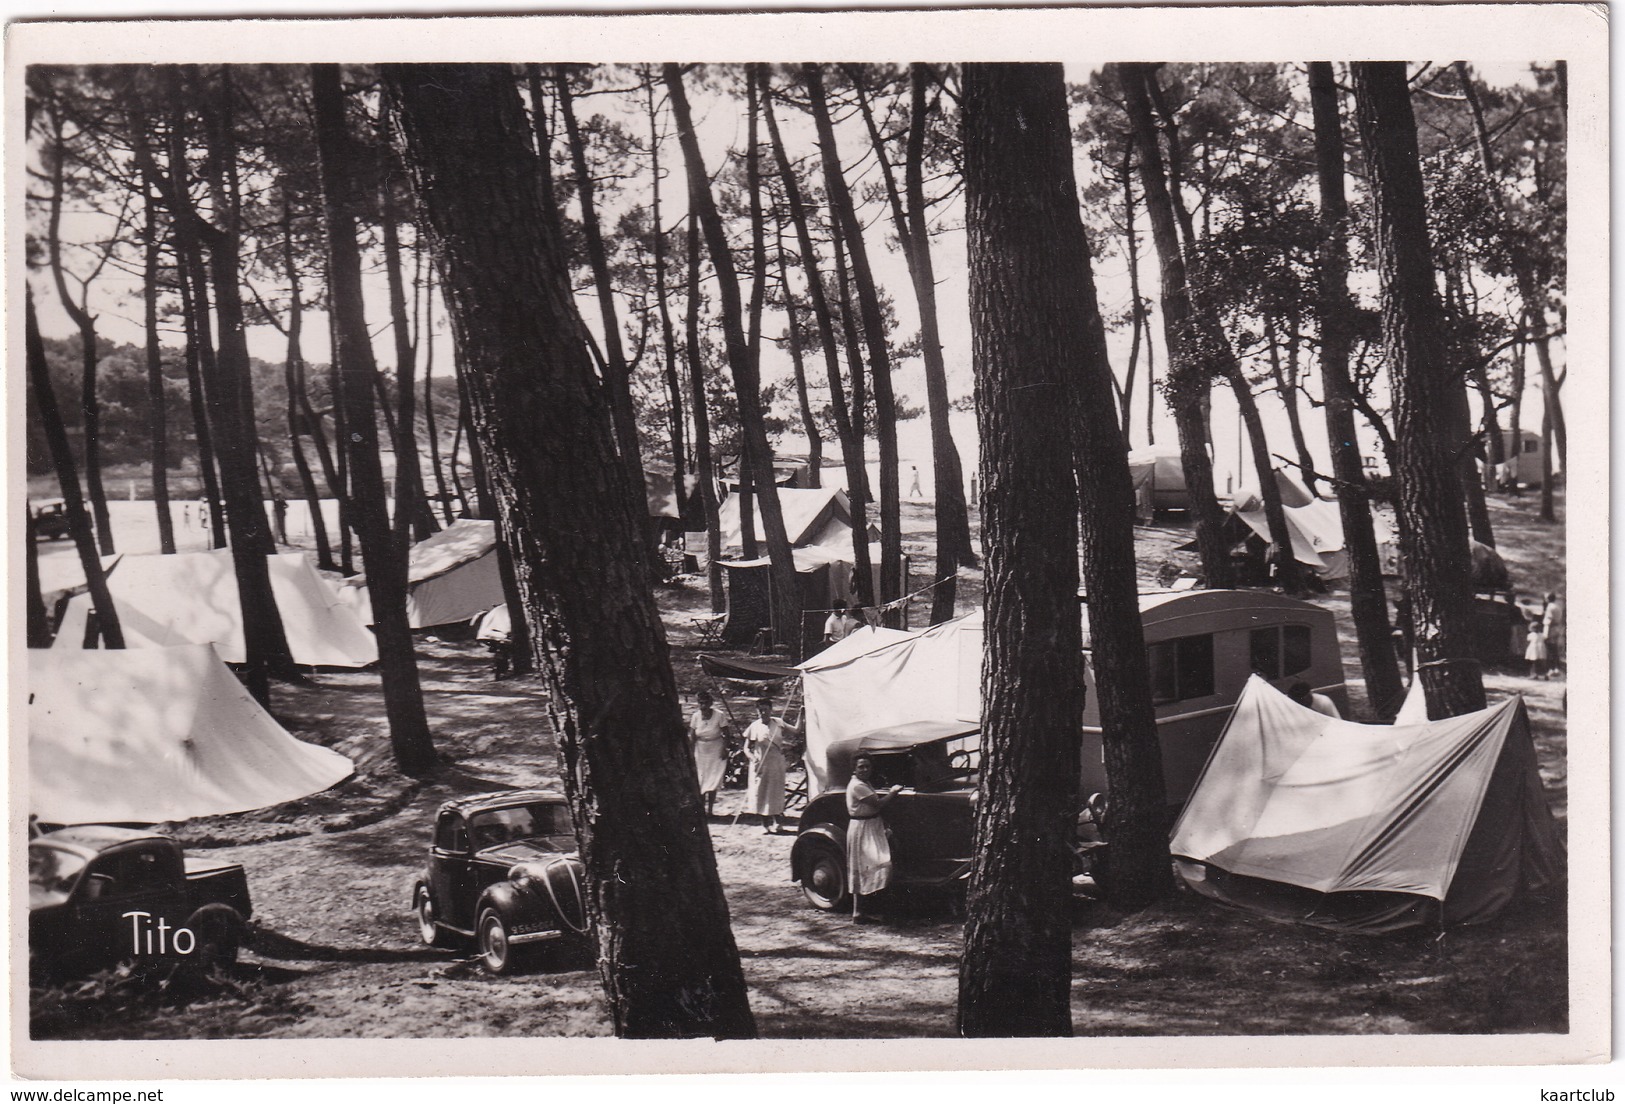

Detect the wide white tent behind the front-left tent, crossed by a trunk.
[{"left": 52, "top": 548, "right": 379, "bottom": 667}]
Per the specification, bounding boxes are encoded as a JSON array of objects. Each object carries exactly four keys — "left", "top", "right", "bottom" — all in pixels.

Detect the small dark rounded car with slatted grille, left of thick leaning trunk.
[{"left": 413, "top": 790, "right": 587, "bottom": 974}]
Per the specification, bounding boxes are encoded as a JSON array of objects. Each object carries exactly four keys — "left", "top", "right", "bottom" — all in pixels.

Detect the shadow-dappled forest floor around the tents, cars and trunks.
[{"left": 29, "top": 494, "right": 1568, "bottom": 1039}]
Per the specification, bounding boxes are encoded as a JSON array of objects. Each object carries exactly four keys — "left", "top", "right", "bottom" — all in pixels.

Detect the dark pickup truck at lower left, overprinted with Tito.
[{"left": 28, "top": 824, "right": 254, "bottom": 979}]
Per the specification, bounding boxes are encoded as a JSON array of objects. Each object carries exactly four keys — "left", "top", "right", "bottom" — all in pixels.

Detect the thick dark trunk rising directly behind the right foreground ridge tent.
[{"left": 1350, "top": 62, "right": 1484, "bottom": 719}]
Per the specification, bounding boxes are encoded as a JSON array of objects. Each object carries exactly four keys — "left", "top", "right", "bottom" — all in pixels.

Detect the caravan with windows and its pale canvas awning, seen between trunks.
[{"left": 801, "top": 590, "right": 1349, "bottom": 803}]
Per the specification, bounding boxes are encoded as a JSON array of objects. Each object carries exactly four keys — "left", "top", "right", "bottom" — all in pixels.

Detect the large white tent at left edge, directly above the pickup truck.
[{"left": 28, "top": 644, "right": 354, "bottom": 824}]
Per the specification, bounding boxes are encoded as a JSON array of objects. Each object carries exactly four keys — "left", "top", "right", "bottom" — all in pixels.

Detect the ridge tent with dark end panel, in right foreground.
[{"left": 1170, "top": 678, "right": 1563, "bottom": 932}]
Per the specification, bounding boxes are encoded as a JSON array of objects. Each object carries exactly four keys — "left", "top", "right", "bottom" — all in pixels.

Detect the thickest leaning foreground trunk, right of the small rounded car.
[{"left": 384, "top": 65, "right": 756, "bottom": 1037}]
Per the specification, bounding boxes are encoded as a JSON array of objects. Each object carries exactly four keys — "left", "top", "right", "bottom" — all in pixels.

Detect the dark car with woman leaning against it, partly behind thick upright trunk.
[{"left": 790, "top": 722, "right": 982, "bottom": 909}]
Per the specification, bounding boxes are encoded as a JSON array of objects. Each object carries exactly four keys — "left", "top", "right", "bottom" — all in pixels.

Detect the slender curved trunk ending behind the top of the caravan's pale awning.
[{"left": 801, "top": 65, "right": 904, "bottom": 621}]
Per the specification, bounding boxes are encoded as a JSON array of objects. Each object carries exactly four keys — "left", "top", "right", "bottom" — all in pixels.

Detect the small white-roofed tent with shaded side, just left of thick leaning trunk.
[{"left": 341, "top": 517, "right": 507, "bottom": 629}]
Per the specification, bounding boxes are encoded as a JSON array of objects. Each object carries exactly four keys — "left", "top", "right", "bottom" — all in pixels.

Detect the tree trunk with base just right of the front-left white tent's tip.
[{"left": 310, "top": 65, "right": 436, "bottom": 776}]
